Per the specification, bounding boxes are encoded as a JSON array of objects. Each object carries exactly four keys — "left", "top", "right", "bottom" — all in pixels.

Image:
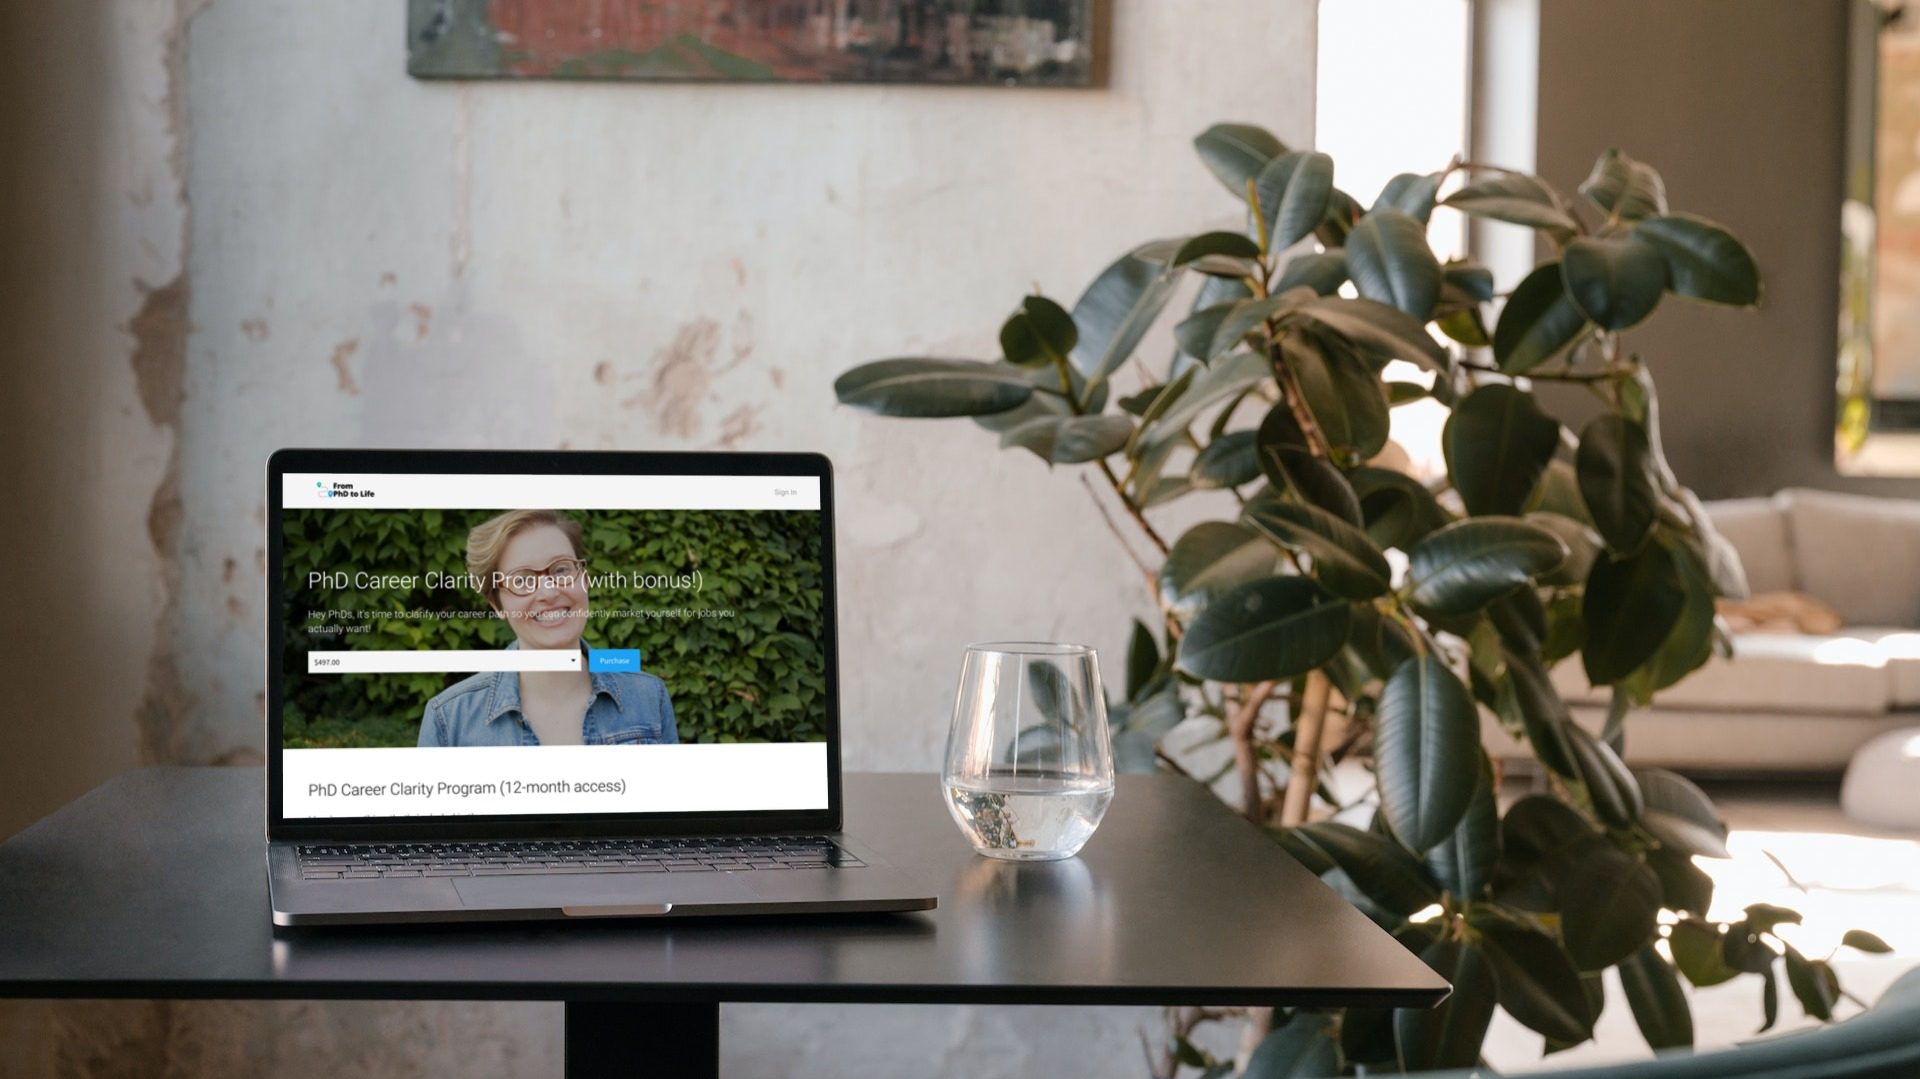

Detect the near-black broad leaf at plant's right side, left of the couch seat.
[{"left": 1580, "top": 543, "right": 1686, "bottom": 685}]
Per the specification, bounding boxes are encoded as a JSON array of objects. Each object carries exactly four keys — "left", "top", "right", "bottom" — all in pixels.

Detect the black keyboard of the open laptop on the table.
[{"left": 296, "top": 835, "right": 866, "bottom": 881}]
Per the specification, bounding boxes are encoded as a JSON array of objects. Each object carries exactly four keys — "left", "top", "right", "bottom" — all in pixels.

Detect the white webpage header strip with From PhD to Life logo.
[{"left": 280, "top": 472, "right": 820, "bottom": 509}]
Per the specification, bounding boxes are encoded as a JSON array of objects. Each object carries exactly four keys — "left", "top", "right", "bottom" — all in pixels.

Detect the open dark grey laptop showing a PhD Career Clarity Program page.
[{"left": 265, "top": 449, "right": 935, "bottom": 925}]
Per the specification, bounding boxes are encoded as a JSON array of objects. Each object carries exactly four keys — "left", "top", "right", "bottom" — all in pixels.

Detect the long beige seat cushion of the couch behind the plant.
[{"left": 1553, "top": 634, "right": 1896, "bottom": 716}]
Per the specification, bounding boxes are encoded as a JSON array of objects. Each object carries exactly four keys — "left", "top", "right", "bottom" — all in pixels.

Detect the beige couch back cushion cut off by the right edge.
[{"left": 1784, "top": 490, "right": 1920, "bottom": 626}]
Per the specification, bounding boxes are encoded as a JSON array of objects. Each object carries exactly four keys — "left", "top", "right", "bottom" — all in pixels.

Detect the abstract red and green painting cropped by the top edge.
[{"left": 407, "top": 0, "right": 1096, "bottom": 86}]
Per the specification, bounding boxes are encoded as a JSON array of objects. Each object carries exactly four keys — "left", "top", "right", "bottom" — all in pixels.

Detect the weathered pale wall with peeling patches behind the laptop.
[{"left": 0, "top": 0, "right": 1313, "bottom": 1075}]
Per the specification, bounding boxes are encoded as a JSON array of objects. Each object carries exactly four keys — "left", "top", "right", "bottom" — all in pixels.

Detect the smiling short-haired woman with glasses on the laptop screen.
[{"left": 420, "top": 509, "right": 680, "bottom": 747}]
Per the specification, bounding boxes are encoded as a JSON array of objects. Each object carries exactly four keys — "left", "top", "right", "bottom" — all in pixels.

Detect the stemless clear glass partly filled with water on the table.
[{"left": 941, "top": 641, "right": 1114, "bottom": 862}]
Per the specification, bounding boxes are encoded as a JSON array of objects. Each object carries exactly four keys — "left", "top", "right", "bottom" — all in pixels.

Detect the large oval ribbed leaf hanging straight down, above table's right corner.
[{"left": 1375, "top": 655, "right": 1480, "bottom": 851}]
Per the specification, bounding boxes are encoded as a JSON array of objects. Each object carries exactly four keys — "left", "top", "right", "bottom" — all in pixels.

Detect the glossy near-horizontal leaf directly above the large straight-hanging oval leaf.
[{"left": 1407, "top": 516, "right": 1567, "bottom": 614}]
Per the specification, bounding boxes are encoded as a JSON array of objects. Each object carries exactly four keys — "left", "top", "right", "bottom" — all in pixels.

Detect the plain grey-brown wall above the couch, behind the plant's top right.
[{"left": 1538, "top": 0, "right": 1920, "bottom": 497}]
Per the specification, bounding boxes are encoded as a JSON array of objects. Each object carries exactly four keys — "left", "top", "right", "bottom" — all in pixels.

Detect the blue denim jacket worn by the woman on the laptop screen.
[{"left": 420, "top": 641, "right": 680, "bottom": 747}]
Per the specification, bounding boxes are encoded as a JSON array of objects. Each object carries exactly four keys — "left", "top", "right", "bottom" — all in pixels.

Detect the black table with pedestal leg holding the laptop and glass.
[{"left": 0, "top": 768, "right": 1448, "bottom": 1075}]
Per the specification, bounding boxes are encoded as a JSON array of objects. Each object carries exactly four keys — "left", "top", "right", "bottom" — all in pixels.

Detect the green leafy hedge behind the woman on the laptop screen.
[{"left": 282, "top": 509, "right": 826, "bottom": 749}]
